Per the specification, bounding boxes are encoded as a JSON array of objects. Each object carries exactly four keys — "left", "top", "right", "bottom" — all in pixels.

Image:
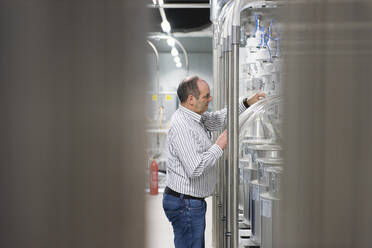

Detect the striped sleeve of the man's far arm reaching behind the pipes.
[{"left": 202, "top": 97, "right": 247, "bottom": 131}]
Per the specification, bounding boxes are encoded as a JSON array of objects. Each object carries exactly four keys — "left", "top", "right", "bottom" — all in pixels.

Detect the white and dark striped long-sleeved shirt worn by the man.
[{"left": 167, "top": 99, "right": 246, "bottom": 197}]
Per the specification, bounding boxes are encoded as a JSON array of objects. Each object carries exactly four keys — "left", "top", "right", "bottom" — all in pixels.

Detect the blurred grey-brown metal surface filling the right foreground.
[{"left": 280, "top": 0, "right": 372, "bottom": 248}]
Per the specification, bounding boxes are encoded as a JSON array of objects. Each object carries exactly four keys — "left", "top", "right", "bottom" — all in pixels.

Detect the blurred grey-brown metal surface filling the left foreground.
[{"left": 0, "top": 0, "right": 147, "bottom": 248}]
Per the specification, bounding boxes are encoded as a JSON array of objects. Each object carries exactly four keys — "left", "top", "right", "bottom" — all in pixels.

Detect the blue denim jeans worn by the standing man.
[{"left": 163, "top": 193, "right": 207, "bottom": 248}]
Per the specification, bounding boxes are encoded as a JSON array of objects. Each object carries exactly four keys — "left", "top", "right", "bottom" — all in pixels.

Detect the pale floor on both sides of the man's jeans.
[{"left": 145, "top": 193, "right": 212, "bottom": 248}]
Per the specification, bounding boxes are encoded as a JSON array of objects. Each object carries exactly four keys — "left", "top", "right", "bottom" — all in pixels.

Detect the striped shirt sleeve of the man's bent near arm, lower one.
[{"left": 173, "top": 130, "right": 223, "bottom": 178}]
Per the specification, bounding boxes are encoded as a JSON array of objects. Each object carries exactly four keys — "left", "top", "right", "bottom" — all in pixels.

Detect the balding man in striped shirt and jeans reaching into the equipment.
[{"left": 163, "top": 76, "right": 265, "bottom": 248}]
